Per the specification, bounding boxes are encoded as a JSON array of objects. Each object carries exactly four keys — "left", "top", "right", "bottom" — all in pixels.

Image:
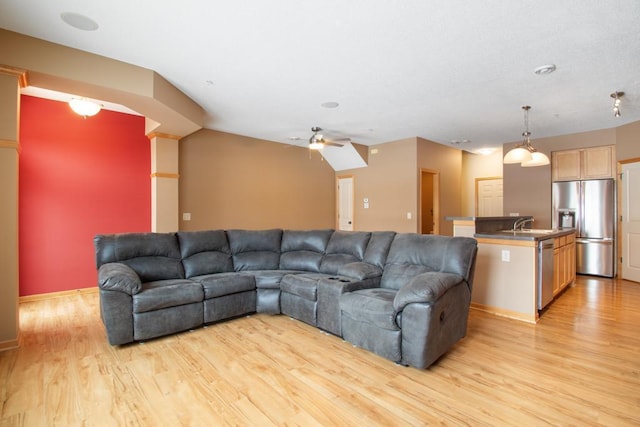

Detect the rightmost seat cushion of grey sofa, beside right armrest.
[{"left": 340, "top": 288, "right": 400, "bottom": 331}]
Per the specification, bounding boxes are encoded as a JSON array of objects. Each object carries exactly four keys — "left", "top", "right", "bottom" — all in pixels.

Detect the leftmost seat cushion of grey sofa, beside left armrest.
[{"left": 133, "top": 279, "right": 204, "bottom": 313}]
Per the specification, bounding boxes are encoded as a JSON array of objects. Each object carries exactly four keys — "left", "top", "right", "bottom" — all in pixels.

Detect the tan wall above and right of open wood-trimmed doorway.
[{"left": 417, "top": 138, "right": 462, "bottom": 236}]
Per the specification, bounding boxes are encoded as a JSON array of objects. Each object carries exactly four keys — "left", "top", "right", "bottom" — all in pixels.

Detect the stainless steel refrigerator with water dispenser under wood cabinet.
[{"left": 551, "top": 179, "right": 616, "bottom": 277}]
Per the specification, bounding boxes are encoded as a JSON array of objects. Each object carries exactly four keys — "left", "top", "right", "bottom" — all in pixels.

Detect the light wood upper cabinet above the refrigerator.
[{"left": 551, "top": 145, "right": 616, "bottom": 181}]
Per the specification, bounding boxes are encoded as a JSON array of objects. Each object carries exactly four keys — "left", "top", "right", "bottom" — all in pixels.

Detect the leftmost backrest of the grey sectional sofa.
[{"left": 93, "top": 233, "right": 184, "bottom": 282}]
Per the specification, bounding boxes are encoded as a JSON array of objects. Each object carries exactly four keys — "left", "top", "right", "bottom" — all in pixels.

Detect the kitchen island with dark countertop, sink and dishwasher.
[{"left": 452, "top": 217, "right": 576, "bottom": 323}]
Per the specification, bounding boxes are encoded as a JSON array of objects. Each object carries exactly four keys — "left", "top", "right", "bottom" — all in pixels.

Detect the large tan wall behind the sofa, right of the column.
[{"left": 179, "top": 129, "right": 335, "bottom": 230}]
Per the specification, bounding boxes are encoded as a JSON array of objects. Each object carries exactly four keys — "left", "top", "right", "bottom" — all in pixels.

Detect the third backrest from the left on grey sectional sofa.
[{"left": 227, "top": 229, "right": 282, "bottom": 271}]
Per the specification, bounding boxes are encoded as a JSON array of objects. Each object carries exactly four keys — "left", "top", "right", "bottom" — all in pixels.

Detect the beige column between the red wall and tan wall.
[{"left": 147, "top": 133, "right": 180, "bottom": 233}]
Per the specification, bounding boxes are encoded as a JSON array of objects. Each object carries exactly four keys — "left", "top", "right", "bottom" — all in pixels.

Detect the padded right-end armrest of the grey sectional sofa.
[{"left": 393, "top": 271, "right": 464, "bottom": 313}]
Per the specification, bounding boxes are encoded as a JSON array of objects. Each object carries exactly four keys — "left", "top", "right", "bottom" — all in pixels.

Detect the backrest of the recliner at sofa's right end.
[{"left": 380, "top": 233, "right": 477, "bottom": 289}]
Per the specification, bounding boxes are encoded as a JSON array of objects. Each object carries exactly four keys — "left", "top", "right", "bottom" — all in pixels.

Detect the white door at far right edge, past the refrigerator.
[{"left": 621, "top": 162, "right": 640, "bottom": 282}]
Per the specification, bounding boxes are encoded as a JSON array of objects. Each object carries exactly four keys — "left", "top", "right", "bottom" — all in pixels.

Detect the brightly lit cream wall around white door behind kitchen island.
[{"left": 461, "top": 148, "right": 502, "bottom": 216}]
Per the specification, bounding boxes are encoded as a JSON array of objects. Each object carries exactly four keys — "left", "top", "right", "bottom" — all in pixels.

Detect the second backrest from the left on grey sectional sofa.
[{"left": 178, "top": 230, "right": 233, "bottom": 278}]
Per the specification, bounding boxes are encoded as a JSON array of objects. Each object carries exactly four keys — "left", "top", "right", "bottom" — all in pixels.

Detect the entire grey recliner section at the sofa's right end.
[{"left": 340, "top": 234, "right": 477, "bottom": 368}]
